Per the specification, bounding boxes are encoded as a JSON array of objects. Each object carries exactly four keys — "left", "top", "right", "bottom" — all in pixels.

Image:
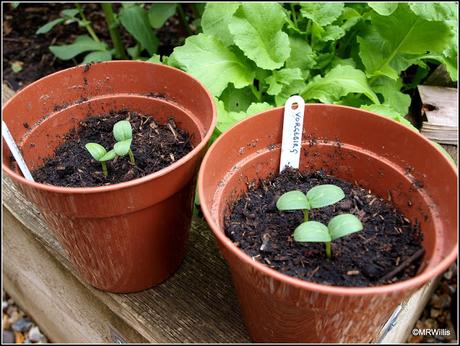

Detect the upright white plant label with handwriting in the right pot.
[{"left": 280, "top": 95, "right": 305, "bottom": 173}]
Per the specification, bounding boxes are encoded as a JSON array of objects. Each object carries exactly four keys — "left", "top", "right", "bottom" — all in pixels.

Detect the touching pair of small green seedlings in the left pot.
[{"left": 85, "top": 120, "right": 136, "bottom": 177}]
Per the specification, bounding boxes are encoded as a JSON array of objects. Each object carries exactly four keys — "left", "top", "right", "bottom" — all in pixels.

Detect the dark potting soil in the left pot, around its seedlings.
[{"left": 32, "top": 111, "right": 193, "bottom": 187}]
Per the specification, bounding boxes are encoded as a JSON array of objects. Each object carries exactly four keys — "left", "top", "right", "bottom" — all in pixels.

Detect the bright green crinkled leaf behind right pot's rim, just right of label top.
[{"left": 302, "top": 65, "right": 380, "bottom": 104}]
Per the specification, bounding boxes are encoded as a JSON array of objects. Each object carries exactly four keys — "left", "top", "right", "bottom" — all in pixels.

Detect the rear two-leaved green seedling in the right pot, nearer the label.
[{"left": 276, "top": 184, "right": 345, "bottom": 222}]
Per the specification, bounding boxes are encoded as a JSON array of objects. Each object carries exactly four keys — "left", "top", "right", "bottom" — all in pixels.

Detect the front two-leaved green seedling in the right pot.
[{"left": 294, "top": 214, "right": 363, "bottom": 258}]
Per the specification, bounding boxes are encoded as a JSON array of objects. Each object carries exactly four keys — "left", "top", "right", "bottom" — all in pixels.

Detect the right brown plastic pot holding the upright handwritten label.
[{"left": 198, "top": 104, "right": 457, "bottom": 343}]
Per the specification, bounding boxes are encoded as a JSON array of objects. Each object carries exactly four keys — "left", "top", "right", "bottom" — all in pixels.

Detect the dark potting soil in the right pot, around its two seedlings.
[{"left": 224, "top": 169, "right": 423, "bottom": 286}]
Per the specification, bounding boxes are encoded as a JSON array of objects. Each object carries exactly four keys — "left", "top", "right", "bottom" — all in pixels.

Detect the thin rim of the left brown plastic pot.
[{"left": 2, "top": 60, "right": 217, "bottom": 194}]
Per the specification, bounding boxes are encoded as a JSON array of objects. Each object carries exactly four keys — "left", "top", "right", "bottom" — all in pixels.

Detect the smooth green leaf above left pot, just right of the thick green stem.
[{"left": 118, "top": 5, "right": 160, "bottom": 54}]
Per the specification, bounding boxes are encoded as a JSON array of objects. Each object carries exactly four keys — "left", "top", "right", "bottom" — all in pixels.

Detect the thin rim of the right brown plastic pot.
[{"left": 198, "top": 103, "right": 458, "bottom": 296}]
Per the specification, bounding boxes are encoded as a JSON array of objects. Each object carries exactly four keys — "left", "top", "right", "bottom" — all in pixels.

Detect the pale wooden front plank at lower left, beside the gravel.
[{"left": 3, "top": 208, "right": 147, "bottom": 343}]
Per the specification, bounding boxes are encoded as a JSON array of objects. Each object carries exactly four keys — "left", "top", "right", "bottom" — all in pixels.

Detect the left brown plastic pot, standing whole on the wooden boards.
[{"left": 3, "top": 61, "right": 216, "bottom": 292}]
